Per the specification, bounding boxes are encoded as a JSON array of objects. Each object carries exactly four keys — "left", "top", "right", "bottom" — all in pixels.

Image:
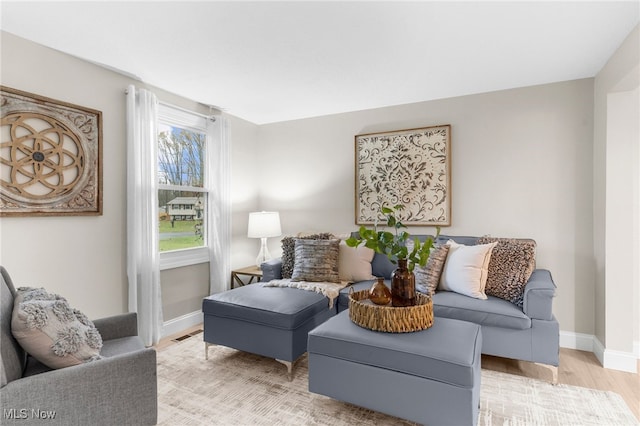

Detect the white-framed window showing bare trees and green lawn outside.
[{"left": 157, "top": 104, "right": 209, "bottom": 269}]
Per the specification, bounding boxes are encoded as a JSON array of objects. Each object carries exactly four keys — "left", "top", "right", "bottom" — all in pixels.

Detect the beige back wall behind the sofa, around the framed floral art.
[{"left": 259, "top": 79, "right": 594, "bottom": 333}]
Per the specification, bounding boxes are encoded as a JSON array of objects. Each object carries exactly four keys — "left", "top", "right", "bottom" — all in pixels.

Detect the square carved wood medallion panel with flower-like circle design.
[{"left": 0, "top": 86, "right": 102, "bottom": 216}]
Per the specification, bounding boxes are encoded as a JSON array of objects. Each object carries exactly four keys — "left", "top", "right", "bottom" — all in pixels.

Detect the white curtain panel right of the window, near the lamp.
[{"left": 206, "top": 115, "right": 231, "bottom": 294}]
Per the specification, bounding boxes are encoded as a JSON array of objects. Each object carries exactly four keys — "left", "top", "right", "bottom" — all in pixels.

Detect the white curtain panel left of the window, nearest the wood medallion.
[{"left": 127, "top": 85, "right": 162, "bottom": 346}]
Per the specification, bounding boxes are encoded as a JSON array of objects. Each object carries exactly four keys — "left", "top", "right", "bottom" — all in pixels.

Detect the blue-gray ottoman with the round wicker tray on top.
[{"left": 308, "top": 311, "right": 482, "bottom": 426}]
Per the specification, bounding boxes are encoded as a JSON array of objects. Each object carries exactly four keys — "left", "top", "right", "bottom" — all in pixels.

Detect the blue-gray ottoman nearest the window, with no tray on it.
[{"left": 202, "top": 284, "right": 336, "bottom": 377}]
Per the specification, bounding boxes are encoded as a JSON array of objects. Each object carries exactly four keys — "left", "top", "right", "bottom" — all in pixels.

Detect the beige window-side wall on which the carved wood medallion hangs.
[{"left": 0, "top": 32, "right": 257, "bottom": 320}]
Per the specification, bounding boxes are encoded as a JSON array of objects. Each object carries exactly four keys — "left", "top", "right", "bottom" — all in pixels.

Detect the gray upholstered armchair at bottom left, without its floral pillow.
[{"left": 0, "top": 266, "right": 158, "bottom": 425}]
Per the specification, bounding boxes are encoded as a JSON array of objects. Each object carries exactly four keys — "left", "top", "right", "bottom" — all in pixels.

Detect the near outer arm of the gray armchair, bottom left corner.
[{"left": 0, "top": 348, "right": 158, "bottom": 425}]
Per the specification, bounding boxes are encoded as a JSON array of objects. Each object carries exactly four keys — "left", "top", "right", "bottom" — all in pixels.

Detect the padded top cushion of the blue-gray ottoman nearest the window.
[{"left": 202, "top": 284, "right": 329, "bottom": 330}]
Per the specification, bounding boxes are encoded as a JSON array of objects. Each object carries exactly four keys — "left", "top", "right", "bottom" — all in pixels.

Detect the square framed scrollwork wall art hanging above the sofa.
[{"left": 355, "top": 125, "right": 451, "bottom": 226}]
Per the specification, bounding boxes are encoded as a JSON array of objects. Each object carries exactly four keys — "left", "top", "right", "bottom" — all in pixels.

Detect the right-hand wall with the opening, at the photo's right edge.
[{"left": 593, "top": 26, "right": 640, "bottom": 366}]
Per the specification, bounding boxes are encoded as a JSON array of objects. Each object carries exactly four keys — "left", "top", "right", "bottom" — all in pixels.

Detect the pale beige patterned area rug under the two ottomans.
[{"left": 158, "top": 334, "right": 639, "bottom": 426}]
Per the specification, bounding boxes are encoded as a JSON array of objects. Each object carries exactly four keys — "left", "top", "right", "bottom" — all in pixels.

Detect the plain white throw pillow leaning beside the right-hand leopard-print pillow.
[{"left": 438, "top": 240, "right": 497, "bottom": 299}]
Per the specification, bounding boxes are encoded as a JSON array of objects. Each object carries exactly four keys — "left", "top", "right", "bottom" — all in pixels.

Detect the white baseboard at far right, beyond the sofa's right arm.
[{"left": 560, "top": 331, "right": 640, "bottom": 373}]
